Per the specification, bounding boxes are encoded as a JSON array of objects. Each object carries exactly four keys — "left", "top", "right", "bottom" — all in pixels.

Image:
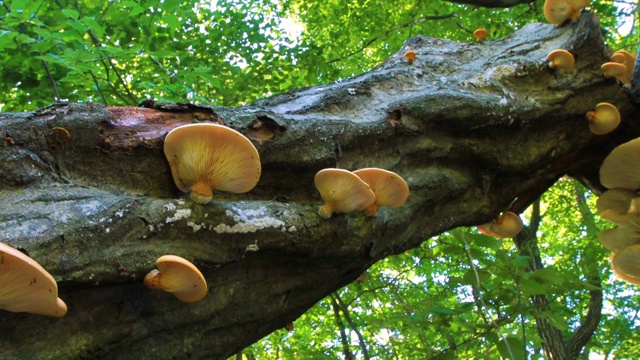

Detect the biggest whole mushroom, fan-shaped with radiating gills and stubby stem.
[{"left": 164, "top": 123, "right": 262, "bottom": 204}]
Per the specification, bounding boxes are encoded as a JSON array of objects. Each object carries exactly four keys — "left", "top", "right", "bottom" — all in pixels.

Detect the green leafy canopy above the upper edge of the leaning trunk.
[{"left": 0, "top": 0, "right": 637, "bottom": 111}]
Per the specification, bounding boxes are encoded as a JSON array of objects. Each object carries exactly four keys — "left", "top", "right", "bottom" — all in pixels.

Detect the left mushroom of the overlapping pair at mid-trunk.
[{"left": 314, "top": 168, "right": 376, "bottom": 219}]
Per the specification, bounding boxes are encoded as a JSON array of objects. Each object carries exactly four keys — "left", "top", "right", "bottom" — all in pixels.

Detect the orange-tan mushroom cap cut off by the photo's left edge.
[{"left": 0, "top": 243, "right": 67, "bottom": 317}]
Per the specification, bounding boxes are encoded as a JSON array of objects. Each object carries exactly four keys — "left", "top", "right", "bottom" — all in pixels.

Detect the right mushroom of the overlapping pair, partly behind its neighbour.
[{"left": 353, "top": 168, "right": 409, "bottom": 215}]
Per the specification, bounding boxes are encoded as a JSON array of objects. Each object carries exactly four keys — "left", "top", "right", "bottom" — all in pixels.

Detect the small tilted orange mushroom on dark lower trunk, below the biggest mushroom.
[{"left": 144, "top": 255, "right": 207, "bottom": 303}]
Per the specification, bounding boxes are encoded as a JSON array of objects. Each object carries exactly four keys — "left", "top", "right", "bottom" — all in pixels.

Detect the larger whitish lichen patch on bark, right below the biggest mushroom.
[{"left": 211, "top": 206, "right": 287, "bottom": 234}]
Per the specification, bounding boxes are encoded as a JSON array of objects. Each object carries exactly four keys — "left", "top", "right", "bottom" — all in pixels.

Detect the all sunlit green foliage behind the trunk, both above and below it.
[{"left": 0, "top": 0, "right": 640, "bottom": 359}]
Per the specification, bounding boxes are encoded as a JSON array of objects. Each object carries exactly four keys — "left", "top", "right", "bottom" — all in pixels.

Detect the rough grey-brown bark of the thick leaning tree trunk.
[{"left": 0, "top": 13, "right": 640, "bottom": 359}]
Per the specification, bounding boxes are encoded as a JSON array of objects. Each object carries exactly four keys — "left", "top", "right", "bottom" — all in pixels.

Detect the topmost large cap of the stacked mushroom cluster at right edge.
[{"left": 600, "top": 138, "right": 640, "bottom": 191}]
